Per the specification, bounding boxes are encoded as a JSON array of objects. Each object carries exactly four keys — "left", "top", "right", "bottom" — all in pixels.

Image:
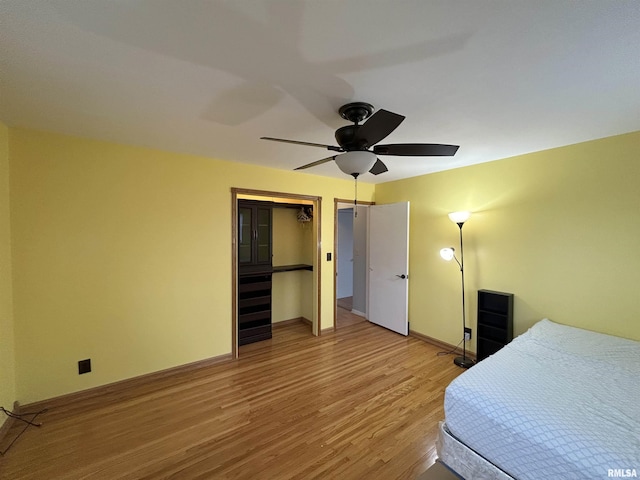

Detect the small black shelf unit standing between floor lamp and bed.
[{"left": 476, "top": 290, "right": 513, "bottom": 361}]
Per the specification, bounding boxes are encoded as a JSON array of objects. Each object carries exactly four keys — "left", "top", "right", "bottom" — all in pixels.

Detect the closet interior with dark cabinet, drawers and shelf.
[{"left": 237, "top": 199, "right": 314, "bottom": 345}]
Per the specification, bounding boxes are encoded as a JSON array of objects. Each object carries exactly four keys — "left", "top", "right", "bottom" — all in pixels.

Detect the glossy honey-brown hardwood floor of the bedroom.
[{"left": 0, "top": 312, "right": 461, "bottom": 480}]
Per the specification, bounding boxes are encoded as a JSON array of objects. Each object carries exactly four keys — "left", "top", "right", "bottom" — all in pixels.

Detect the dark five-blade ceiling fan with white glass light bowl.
[{"left": 260, "top": 102, "right": 459, "bottom": 179}]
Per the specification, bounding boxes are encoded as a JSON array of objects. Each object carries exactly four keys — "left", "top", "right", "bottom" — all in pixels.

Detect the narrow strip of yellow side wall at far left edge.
[{"left": 0, "top": 124, "right": 16, "bottom": 410}]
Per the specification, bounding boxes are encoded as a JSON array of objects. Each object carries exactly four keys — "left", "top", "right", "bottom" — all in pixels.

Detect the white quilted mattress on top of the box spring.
[{"left": 444, "top": 319, "right": 640, "bottom": 480}]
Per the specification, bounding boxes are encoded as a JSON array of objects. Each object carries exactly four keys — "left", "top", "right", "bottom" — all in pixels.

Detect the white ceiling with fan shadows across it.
[{"left": 0, "top": 0, "right": 640, "bottom": 183}]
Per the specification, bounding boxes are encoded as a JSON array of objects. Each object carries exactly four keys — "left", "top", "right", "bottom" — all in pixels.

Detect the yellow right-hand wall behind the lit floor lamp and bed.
[{"left": 376, "top": 132, "right": 640, "bottom": 346}]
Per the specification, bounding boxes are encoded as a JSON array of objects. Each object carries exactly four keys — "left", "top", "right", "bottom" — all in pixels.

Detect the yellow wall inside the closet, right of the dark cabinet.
[{"left": 271, "top": 208, "right": 314, "bottom": 323}]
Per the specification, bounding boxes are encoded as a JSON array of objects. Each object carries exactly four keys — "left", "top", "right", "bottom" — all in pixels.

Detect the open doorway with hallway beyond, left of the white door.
[{"left": 333, "top": 199, "right": 373, "bottom": 328}]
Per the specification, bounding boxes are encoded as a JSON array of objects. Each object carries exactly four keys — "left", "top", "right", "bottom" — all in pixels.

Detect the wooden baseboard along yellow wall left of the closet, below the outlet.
[{"left": 21, "top": 353, "right": 233, "bottom": 410}]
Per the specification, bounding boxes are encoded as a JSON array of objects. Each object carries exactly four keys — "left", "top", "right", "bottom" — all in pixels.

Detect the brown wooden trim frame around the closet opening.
[{"left": 231, "top": 187, "right": 322, "bottom": 359}]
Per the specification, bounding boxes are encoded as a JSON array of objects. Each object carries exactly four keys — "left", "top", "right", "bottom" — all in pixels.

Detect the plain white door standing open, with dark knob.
[{"left": 369, "top": 202, "right": 409, "bottom": 335}]
